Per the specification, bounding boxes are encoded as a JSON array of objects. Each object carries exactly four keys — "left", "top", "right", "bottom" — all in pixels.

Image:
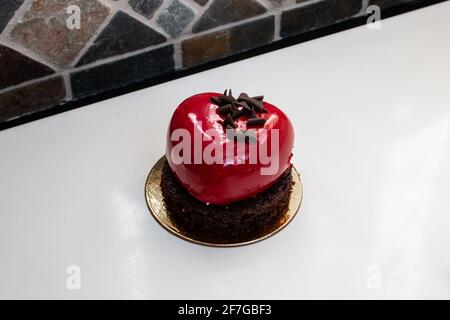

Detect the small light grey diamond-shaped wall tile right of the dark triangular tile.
[{"left": 158, "top": 0, "right": 195, "bottom": 38}]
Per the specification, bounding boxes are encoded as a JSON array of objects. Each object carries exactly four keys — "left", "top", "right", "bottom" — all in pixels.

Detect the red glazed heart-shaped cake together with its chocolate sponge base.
[{"left": 161, "top": 90, "right": 294, "bottom": 241}]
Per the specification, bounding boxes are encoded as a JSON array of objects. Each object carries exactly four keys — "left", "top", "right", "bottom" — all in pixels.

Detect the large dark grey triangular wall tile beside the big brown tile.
[{"left": 78, "top": 11, "right": 166, "bottom": 65}]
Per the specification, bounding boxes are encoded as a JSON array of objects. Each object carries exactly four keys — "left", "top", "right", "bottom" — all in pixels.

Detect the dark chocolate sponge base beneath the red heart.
[{"left": 161, "top": 161, "right": 293, "bottom": 243}]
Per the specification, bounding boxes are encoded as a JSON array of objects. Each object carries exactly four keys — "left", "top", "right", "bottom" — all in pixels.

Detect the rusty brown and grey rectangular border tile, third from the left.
[{"left": 182, "top": 16, "right": 274, "bottom": 67}]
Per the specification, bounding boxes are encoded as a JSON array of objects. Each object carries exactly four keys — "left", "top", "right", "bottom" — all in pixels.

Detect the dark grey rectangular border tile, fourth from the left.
[{"left": 280, "top": 0, "right": 362, "bottom": 37}]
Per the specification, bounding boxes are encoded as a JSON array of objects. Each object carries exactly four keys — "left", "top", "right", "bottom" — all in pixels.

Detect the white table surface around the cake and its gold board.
[{"left": 0, "top": 2, "right": 450, "bottom": 299}]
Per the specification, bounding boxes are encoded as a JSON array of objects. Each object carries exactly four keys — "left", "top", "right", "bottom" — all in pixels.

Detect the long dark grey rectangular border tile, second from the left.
[{"left": 71, "top": 46, "right": 174, "bottom": 99}]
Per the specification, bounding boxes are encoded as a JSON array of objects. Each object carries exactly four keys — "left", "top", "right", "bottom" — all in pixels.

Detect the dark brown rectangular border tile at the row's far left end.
[{"left": 0, "top": 77, "right": 66, "bottom": 122}]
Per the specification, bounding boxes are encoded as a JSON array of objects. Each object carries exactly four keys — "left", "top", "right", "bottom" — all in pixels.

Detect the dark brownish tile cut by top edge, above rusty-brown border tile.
[{"left": 192, "top": 0, "right": 267, "bottom": 33}]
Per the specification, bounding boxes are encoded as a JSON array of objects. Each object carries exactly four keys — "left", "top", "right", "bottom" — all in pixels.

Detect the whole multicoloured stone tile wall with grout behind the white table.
[{"left": 0, "top": 0, "right": 423, "bottom": 124}]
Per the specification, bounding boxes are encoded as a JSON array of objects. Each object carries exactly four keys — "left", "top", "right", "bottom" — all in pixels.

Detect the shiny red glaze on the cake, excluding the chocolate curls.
[{"left": 166, "top": 93, "right": 294, "bottom": 205}]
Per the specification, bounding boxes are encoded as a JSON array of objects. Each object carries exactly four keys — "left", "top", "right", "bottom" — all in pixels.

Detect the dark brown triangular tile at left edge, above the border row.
[{"left": 0, "top": 45, "right": 55, "bottom": 89}]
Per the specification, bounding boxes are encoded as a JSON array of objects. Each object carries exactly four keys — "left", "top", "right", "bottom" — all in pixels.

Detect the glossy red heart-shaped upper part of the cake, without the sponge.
[{"left": 166, "top": 93, "right": 294, "bottom": 205}]
